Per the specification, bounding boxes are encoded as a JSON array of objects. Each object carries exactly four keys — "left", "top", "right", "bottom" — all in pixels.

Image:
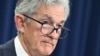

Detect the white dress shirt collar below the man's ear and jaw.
[{"left": 14, "top": 36, "right": 29, "bottom": 56}]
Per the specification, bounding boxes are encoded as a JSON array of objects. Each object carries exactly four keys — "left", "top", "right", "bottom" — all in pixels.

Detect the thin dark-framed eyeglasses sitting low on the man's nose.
[{"left": 22, "top": 14, "right": 70, "bottom": 39}]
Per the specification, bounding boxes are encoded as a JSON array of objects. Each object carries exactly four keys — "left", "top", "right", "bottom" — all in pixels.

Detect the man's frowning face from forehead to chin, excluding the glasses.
[{"left": 23, "top": 6, "right": 64, "bottom": 55}]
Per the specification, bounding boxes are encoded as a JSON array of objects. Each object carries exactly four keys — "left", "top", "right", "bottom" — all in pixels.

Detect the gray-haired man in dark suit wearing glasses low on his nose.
[{"left": 0, "top": 0, "right": 69, "bottom": 56}]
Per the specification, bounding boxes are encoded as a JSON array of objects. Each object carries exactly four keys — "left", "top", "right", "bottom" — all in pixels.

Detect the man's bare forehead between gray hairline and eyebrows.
[{"left": 33, "top": 5, "right": 65, "bottom": 21}]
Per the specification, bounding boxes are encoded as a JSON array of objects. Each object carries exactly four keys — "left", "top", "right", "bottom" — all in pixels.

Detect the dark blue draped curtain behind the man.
[{"left": 0, "top": 0, "right": 100, "bottom": 56}]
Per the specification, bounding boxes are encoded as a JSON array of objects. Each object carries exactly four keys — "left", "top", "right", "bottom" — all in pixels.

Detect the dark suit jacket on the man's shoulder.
[{"left": 0, "top": 40, "right": 17, "bottom": 56}]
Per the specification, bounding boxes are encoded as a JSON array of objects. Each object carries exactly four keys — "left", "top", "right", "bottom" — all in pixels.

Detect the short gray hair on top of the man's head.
[{"left": 15, "top": 0, "right": 69, "bottom": 18}]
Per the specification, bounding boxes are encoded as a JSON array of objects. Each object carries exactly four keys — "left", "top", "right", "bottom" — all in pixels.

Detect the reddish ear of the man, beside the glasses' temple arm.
[{"left": 15, "top": 14, "right": 25, "bottom": 33}]
